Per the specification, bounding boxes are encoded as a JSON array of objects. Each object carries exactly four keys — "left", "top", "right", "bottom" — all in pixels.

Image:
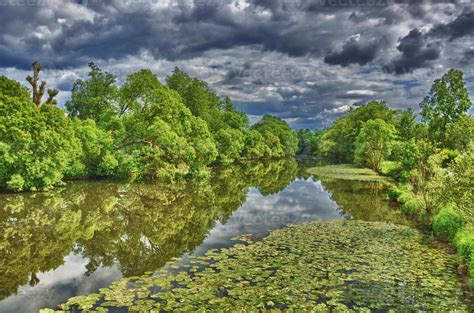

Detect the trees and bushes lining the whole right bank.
[{"left": 297, "top": 69, "right": 474, "bottom": 289}]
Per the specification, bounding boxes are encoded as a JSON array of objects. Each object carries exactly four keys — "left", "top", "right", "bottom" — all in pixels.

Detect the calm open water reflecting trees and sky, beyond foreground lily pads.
[{"left": 0, "top": 160, "right": 406, "bottom": 312}]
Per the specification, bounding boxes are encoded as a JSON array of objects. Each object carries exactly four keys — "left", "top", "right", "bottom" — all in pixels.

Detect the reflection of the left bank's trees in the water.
[{"left": 0, "top": 159, "right": 298, "bottom": 300}]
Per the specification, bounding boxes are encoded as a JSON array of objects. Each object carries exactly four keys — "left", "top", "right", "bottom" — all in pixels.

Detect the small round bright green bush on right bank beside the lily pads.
[{"left": 433, "top": 205, "right": 465, "bottom": 241}]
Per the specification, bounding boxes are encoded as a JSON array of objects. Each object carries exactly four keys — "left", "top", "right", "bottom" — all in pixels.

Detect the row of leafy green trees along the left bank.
[{"left": 0, "top": 62, "right": 298, "bottom": 191}]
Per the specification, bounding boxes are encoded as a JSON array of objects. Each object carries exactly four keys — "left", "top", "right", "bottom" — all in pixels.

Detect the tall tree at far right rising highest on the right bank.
[{"left": 420, "top": 69, "right": 471, "bottom": 147}]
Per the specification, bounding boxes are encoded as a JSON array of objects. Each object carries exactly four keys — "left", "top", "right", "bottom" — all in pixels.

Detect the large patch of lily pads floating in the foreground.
[{"left": 43, "top": 221, "right": 468, "bottom": 312}]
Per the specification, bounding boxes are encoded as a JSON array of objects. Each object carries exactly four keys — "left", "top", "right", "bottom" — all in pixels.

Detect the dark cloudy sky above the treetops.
[{"left": 0, "top": 0, "right": 474, "bottom": 128}]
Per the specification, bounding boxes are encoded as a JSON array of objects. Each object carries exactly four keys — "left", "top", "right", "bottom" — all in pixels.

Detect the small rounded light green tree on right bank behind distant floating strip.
[{"left": 355, "top": 119, "right": 395, "bottom": 172}]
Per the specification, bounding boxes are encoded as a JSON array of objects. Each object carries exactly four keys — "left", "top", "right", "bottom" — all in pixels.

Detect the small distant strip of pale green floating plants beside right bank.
[{"left": 308, "top": 164, "right": 390, "bottom": 183}]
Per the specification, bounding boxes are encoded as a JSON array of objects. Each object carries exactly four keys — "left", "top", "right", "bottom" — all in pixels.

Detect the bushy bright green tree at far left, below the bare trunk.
[{"left": 0, "top": 95, "right": 80, "bottom": 191}]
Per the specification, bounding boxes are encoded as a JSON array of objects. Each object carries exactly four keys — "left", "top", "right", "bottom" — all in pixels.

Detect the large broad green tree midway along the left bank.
[{"left": 117, "top": 70, "right": 217, "bottom": 179}]
